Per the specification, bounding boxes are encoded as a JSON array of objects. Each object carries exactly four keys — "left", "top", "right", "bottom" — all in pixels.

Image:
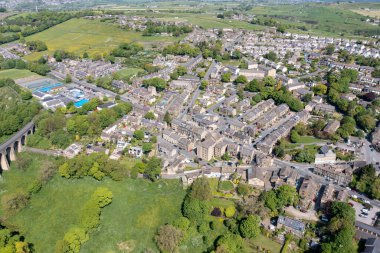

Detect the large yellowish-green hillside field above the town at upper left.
[{"left": 25, "top": 19, "right": 180, "bottom": 60}]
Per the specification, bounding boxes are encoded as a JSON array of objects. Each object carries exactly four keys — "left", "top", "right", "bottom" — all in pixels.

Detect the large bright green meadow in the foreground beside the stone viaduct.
[{"left": 0, "top": 153, "right": 185, "bottom": 252}]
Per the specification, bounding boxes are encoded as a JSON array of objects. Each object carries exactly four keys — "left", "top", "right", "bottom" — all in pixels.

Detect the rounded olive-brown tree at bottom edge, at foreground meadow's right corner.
[{"left": 154, "top": 225, "right": 183, "bottom": 253}]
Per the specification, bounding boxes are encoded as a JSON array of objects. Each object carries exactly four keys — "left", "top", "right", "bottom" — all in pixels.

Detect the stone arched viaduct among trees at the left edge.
[{"left": 0, "top": 121, "right": 36, "bottom": 175}]
